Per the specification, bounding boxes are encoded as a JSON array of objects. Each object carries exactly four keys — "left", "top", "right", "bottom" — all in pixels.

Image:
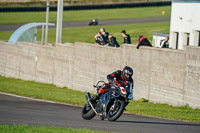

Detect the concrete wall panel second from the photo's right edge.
[{"left": 149, "top": 49, "right": 186, "bottom": 105}]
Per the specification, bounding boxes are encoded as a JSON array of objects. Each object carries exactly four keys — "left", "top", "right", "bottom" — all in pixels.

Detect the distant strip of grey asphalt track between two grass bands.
[{"left": 0, "top": 17, "right": 170, "bottom": 31}]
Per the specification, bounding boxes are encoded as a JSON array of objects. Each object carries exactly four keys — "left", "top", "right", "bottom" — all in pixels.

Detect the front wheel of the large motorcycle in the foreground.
[{"left": 108, "top": 100, "right": 125, "bottom": 121}]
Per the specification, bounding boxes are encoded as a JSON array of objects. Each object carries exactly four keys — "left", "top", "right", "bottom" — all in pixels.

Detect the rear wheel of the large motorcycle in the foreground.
[{"left": 82, "top": 103, "right": 96, "bottom": 120}]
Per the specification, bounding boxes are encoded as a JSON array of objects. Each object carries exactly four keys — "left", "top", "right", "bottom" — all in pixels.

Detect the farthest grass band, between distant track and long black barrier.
[{"left": 0, "top": 6, "right": 171, "bottom": 24}]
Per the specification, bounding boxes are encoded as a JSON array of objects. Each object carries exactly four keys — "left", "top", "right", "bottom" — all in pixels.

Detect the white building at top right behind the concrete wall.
[{"left": 169, "top": 0, "right": 200, "bottom": 49}]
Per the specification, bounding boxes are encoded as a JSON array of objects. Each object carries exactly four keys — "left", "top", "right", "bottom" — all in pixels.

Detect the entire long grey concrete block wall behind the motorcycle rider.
[{"left": 0, "top": 42, "right": 200, "bottom": 108}]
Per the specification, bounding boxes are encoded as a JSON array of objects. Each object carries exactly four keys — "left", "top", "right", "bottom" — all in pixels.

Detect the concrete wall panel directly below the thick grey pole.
[{"left": 53, "top": 45, "right": 74, "bottom": 88}]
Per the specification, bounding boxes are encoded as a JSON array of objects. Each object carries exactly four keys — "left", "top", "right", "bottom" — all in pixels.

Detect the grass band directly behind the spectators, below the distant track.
[{"left": 0, "top": 22, "right": 170, "bottom": 44}]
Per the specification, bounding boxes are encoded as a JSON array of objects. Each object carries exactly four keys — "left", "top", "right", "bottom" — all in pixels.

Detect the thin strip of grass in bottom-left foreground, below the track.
[{"left": 0, "top": 125, "right": 114, "bottom": 133}]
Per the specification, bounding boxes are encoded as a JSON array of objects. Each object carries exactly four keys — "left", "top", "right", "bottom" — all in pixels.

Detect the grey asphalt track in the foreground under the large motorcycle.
[{"left": 0, "top": 93, "right": 200, "bottom": 133}]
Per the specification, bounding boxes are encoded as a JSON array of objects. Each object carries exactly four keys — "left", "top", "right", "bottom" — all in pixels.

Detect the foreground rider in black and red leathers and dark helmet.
[{"left": 90, "top": 66, "right": 133, "bottom": 103}]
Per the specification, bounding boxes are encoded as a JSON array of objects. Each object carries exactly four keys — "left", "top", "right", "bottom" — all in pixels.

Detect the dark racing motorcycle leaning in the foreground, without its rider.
[{"left": 82, "top": 81, "right": 128, "bottom": 121}]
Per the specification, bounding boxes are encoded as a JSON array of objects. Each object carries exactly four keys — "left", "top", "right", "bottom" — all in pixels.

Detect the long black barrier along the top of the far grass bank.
[{"left": 0, "top": 1, "right": 171, "bottom": 12}]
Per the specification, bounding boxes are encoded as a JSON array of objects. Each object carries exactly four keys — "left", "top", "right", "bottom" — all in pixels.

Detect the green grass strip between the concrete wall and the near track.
[{"left": 0, "top": 76, "right": 200, "bottom": 122}]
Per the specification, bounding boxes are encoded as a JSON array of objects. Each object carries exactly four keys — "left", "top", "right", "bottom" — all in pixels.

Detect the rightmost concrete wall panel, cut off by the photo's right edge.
[{"left": 183, "top": 46, "right": 200, "bottom": 108}]
